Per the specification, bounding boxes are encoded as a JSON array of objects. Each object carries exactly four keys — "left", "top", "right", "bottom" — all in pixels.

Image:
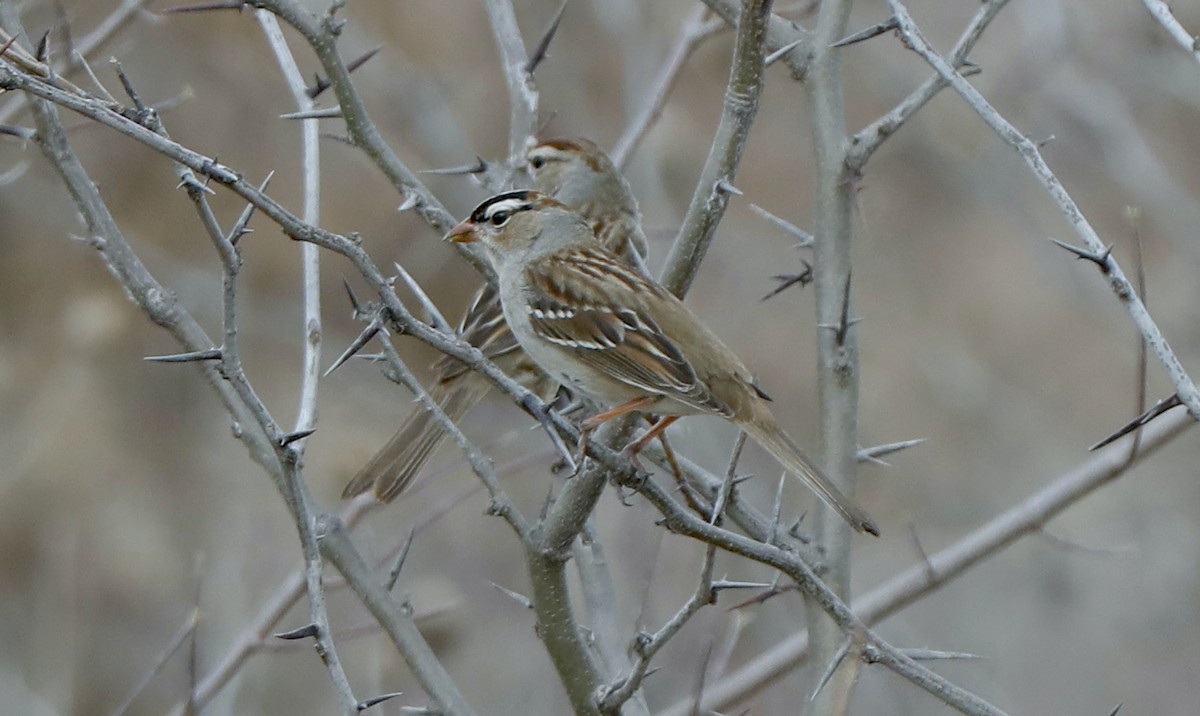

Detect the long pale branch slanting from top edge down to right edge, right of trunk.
[{"left": 888, "top": 0, "right": 1200, "bottom": 420}]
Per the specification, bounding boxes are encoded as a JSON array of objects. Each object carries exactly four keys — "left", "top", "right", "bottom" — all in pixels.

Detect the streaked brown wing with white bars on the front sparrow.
[{"left": 526, "top": 247, "right": 732, "bottom": 416}]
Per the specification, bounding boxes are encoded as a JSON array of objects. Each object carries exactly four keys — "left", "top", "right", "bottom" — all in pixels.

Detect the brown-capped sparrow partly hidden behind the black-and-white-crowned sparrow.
[{"left": 342, "top": 138, "right": 646, "bottom": 503}]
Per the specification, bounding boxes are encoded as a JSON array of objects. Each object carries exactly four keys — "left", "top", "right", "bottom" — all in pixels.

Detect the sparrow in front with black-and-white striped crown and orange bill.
[{"left": 446, "top": 191, "right": 880, "bottom": 535}]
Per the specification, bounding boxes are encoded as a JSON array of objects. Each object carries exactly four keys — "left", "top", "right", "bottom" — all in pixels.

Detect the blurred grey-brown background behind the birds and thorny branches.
[{"left": 0, "top": 0, "right": 1200, "bottom": 715}]
